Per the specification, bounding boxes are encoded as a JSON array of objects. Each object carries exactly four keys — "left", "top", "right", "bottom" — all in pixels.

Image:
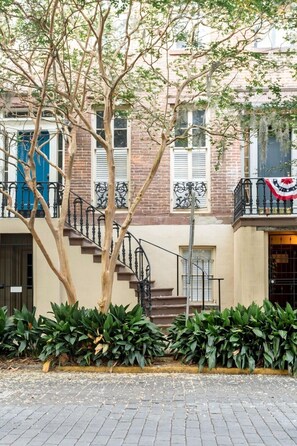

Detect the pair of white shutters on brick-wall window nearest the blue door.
[{"left": 95, "top": 148, "right": 128, "bottom": 182}]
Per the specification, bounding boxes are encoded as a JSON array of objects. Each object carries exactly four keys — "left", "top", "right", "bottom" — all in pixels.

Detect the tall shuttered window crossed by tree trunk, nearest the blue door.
[{"left": 95, "top": 111, "right": 128, "bottom": 209}]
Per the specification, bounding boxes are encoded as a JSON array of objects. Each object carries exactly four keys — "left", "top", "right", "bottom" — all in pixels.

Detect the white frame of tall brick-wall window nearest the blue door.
[{"left": 91, "top": 109, "right": 131, "bottom": 213}]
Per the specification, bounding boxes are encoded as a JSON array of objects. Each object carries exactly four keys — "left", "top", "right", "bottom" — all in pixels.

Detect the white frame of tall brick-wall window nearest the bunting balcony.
[{"left": 170, "top": 108, "right": 210, "bottom": 213}]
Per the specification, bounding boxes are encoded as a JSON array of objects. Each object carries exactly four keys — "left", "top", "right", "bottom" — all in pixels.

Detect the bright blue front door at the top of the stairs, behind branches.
[{"left": 16, "top": 131, "right": 49, "bottom": 217}]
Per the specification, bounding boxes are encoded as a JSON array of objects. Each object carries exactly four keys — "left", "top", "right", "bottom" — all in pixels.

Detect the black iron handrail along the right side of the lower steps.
[{"left": 139, "top": 239, "right": 224, "bottom": 310}]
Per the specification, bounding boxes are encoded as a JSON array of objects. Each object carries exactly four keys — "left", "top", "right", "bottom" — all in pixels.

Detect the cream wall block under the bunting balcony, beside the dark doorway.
[{"left": 234, "top": 227, "right": 268, "bottom": 305}]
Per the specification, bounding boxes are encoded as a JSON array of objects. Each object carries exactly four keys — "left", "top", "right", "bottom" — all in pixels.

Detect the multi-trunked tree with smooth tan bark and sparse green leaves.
[{"left": 0, "top": 0, "right": 289, "bottom": 311}]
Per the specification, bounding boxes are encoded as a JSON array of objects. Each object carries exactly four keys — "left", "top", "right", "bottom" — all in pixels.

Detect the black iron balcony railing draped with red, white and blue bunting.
[{"left": 234, "top": 178, "right": 297, "bottom": 221}]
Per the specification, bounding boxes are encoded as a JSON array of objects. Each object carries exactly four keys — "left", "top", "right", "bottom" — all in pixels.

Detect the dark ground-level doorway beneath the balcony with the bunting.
[{"left": 269, "top": 233, "right": 297, "bottom": 308}]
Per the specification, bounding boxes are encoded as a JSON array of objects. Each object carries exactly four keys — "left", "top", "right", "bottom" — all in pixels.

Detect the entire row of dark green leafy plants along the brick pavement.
[{"left": 0, "top": 301, "right": 297, "bottom": 375}]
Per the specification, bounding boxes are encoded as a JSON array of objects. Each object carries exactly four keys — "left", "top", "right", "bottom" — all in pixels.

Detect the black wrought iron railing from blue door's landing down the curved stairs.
[{"left": 0, "top": 182, "right": 151, "bottom": 315}]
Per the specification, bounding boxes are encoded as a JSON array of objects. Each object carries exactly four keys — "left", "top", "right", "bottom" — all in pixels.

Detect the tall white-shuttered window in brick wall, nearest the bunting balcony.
[{"left": 173, "top": 110, "right": 207, "bottom": 209}]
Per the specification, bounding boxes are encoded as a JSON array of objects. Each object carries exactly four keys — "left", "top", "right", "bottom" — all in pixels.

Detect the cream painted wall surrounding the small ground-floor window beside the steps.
[{"left": 130, "top": 216, "right": 234, "bottom": 308}]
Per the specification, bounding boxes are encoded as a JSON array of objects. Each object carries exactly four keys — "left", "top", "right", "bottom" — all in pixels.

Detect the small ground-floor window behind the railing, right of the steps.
[{"left": 182, "top": 248, "right": 214, "bottom": 302}]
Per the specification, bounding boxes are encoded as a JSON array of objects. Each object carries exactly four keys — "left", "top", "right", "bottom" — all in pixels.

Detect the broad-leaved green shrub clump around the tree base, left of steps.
[{"left": 40, "top": 304, "right": 166, "bottom": 367}]
